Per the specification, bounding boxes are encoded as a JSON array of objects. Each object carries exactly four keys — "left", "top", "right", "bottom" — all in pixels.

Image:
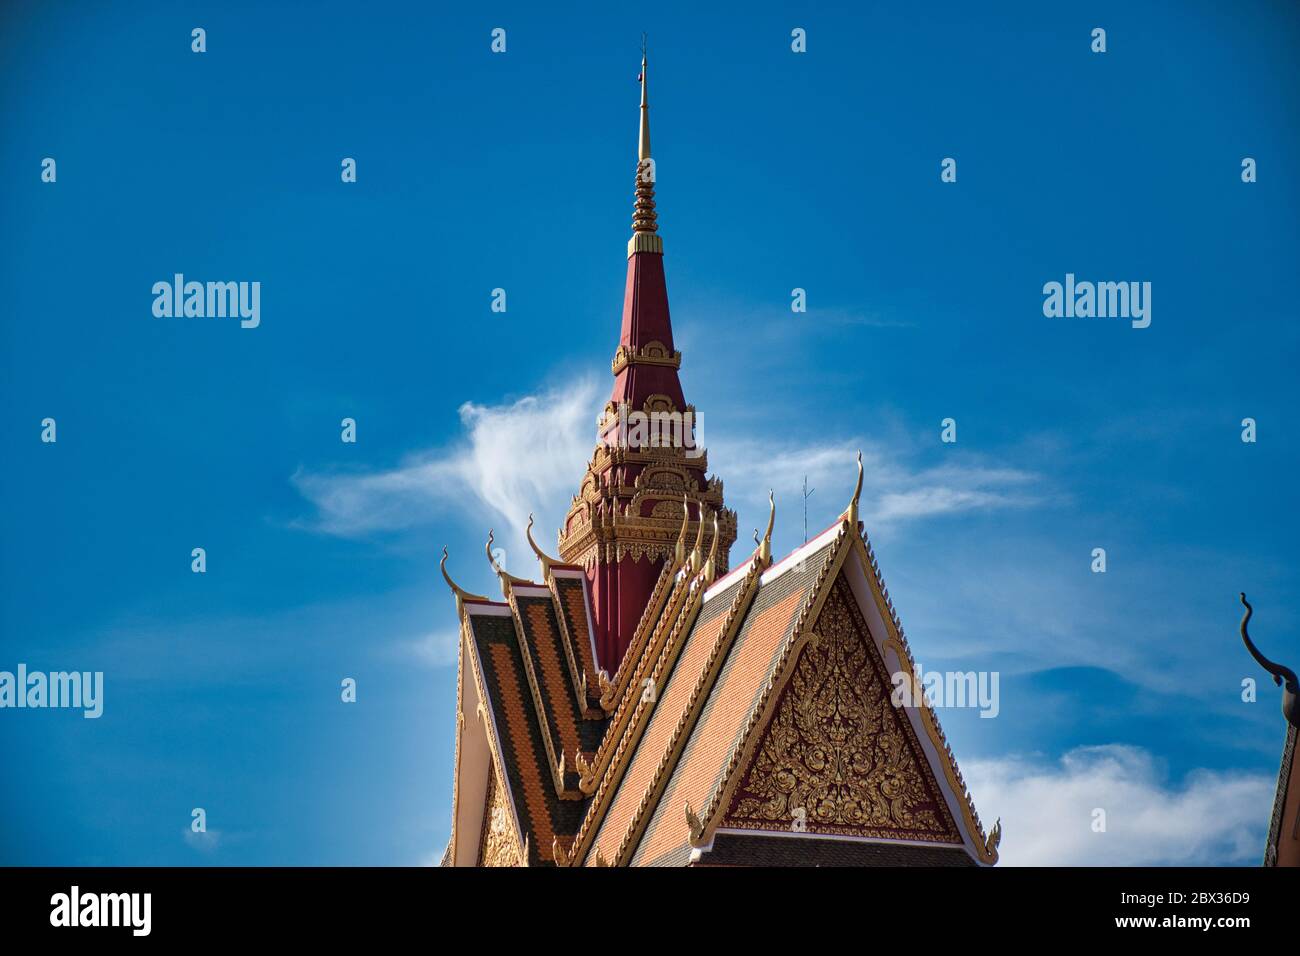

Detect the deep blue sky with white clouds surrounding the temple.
[{"left": 0, "top": 3, "right": 1300, "bottom": 865}]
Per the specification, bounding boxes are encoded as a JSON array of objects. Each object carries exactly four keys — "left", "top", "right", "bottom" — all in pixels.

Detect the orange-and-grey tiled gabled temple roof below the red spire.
[{"left": 441, "top": 463, "right": 1000, "bottom": 866}]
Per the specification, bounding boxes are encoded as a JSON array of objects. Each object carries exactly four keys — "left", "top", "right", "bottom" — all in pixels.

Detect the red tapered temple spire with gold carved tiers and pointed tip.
[{"left": 559, "top": 56, "right": 736, "bottom": 674}]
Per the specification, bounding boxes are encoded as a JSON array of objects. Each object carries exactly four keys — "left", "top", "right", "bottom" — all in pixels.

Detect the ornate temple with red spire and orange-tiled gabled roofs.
[{"left": 442, "top": 57, "right": 1001, "bottom": 866}]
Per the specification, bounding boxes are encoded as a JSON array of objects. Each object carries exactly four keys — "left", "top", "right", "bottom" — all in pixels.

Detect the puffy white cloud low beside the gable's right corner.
[{"left": 963, "top": 744, "right": 1277, "bottom": 866}]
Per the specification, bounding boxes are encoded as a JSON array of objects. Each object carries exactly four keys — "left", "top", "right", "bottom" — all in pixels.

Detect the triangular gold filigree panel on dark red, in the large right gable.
[{"left": 723, "top": 580, "right": 961, "bottom": 843}]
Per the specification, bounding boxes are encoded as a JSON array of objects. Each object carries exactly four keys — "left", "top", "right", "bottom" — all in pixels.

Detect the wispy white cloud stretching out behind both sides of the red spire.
[{"left": 293, "top": 380, "right": 1040, "bottom": 564}]
